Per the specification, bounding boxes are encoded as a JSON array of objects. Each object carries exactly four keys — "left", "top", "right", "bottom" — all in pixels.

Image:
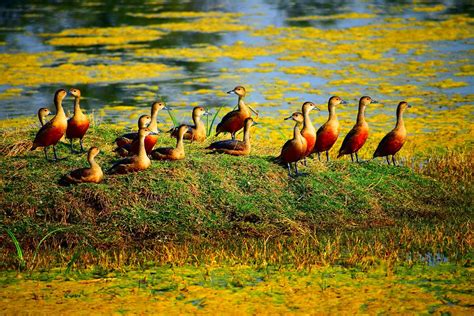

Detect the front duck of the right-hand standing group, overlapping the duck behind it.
[{"left": 277, "top": 112, "right": 307, "bottom": 176}]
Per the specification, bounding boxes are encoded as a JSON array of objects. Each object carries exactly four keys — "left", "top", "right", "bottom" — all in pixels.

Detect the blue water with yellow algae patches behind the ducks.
[{"left": 0, "top": 0, "right": 474, "bottom": 157}]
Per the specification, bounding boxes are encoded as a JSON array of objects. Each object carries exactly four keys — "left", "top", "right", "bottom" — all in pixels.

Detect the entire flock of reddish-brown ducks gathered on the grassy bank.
[{"left": 31, "top": 86, "right": 409, "bottom": 184}]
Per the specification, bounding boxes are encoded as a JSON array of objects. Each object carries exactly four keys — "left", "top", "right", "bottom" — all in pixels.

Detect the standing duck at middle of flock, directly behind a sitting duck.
[{"left": 216, "top": 86, "right": 258, "bottom": 139}]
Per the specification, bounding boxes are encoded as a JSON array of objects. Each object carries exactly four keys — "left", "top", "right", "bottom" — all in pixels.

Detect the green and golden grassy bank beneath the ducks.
[{"left": 0, "top": 127, "right": 473, "bottom": 269}]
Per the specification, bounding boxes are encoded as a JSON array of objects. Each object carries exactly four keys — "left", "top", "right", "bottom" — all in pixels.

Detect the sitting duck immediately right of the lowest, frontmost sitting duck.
[{"left": 108, "top": 127, "right": 154, "bottom": 174}]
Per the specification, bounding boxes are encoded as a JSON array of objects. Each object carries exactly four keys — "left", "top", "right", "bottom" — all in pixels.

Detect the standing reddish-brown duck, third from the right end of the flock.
[{"left": 313, "top": 96, "right": 347, "bottom": 161}]
